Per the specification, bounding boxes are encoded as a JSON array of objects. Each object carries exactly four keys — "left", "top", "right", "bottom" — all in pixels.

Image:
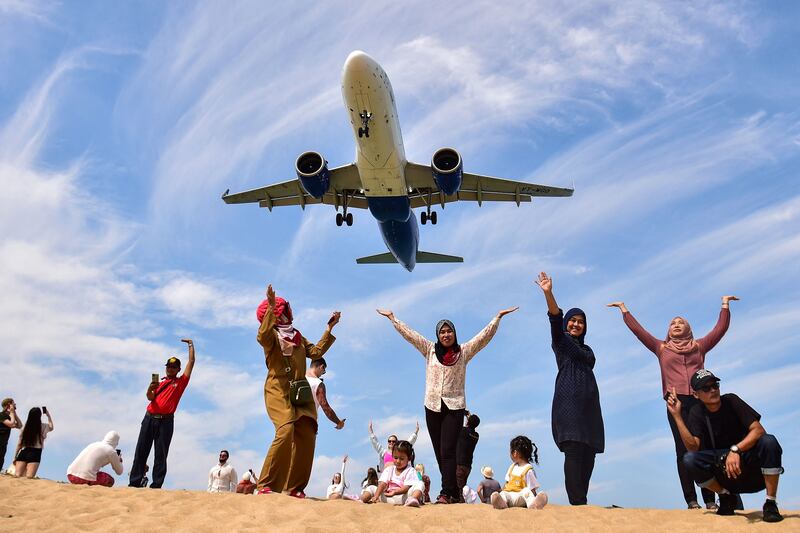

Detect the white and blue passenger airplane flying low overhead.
[{"left": 222, "top": 50, "right": 573, "bottom": 272}]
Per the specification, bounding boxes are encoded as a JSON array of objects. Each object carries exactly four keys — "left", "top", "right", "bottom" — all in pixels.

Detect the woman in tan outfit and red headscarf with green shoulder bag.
[{"left": 256, "top": 285, "right": 341, "bottom": 498}]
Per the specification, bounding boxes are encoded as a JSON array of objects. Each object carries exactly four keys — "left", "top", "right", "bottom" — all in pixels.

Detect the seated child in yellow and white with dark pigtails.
[{"left": 491, "top": 435, "right": 547, "bottom": 509}]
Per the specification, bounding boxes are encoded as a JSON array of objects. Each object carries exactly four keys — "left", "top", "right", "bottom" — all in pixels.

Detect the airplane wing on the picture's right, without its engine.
[{"left": 405, "top": 162, "right": 573, "bottom": 207}]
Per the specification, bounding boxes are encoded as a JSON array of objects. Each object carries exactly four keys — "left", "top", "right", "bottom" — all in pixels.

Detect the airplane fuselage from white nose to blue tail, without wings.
[{"left": 342, "top": 51, "right": 419, "bottom": 271}]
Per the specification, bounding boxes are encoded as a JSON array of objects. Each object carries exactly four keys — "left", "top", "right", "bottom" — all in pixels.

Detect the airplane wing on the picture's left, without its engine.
[{"left": 222, "top": 163, "right": 367, "bottom": 211}]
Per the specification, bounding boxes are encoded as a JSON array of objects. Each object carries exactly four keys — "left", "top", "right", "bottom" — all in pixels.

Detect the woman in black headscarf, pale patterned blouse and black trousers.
[{"left": 378, "top": 307, "right": 519, "bottom": 503}]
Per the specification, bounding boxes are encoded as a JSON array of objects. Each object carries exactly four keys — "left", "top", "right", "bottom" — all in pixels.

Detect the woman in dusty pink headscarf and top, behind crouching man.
[{"left": 608, "top": 296, "right": 739, "bottom": 509}]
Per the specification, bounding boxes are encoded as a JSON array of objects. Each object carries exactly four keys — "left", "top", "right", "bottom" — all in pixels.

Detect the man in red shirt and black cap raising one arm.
[{"left": 128, "top": 339, "right": 194, "bottom": 489}]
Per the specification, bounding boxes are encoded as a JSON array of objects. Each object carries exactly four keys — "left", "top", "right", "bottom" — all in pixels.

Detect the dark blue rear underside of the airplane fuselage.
[{"left": 367, "top": 196, "right": 419, "bottom": 272}]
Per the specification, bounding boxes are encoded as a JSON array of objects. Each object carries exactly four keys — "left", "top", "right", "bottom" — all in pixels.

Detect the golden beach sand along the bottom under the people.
[{"left": 0, "top": 476, "right": 800, "bottom": 533}]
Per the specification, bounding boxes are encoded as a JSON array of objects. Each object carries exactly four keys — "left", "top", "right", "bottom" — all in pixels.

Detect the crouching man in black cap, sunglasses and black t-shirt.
[{"left": 667, "top": 369, "right": 783, "bottom": 522}]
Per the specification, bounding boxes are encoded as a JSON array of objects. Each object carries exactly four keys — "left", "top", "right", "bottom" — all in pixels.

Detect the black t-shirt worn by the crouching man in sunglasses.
[{"left": 686, "top": 394, "right": 761, "bottom": 450}]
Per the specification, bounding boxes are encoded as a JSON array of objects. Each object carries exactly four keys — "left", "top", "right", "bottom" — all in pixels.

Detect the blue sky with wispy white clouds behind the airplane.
[{"left": 0, "top": 0, "right": 800, "bottom": 509}]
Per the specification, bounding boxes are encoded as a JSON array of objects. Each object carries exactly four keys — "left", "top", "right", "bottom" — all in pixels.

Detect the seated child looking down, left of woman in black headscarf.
[{"left": 370, "top": 440, "right": 425, "bottom": 507}]
